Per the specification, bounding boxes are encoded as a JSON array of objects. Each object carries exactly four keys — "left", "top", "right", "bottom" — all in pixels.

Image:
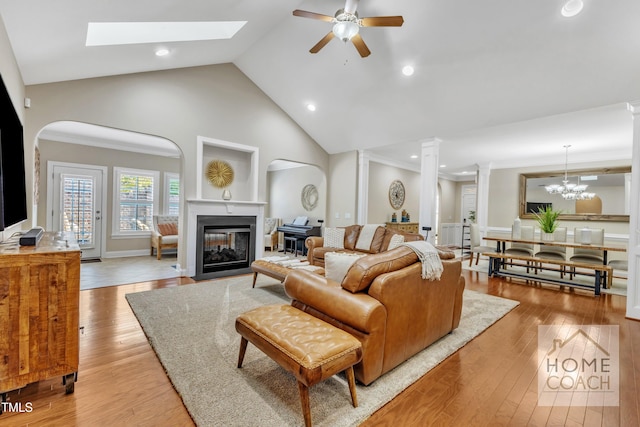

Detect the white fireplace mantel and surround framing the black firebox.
[{"left": 185, "top": 199, "right": 267, "bottom": 276}]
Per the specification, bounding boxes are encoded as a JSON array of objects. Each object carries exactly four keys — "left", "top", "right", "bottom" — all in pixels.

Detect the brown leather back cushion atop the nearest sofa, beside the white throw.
[{"left": 340, "top": 246, "right": 418, "bottom": 293}]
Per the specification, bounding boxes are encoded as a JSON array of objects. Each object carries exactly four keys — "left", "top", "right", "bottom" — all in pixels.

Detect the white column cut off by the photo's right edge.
[{"left": 627, "top": 101, "right": 640, "bottom": 320}]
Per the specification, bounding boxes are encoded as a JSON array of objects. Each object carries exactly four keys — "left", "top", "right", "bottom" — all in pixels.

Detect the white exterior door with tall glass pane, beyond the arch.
[{"left": 47, "top": 162, "right": 106, "bottom": 259}]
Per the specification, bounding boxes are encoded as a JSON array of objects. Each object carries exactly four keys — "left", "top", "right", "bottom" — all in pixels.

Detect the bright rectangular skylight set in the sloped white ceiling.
[{"left": 86, "top": 21, "right": 247, "bottom": 46}]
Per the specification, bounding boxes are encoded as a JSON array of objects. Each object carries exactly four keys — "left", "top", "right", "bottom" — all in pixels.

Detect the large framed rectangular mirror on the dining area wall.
[{"left": 519, "top": 166, "right": 631, "bottom": 222}]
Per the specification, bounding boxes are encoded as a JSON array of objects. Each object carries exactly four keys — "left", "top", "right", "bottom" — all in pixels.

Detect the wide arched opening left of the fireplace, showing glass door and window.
[{"left": 34, "top": 121, "right": 182, "bottom": 283}]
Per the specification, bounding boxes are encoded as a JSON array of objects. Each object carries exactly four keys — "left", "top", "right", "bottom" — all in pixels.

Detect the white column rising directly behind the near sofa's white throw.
[{"left": 418, "top": 138, "right": 442, "bottom": 243}]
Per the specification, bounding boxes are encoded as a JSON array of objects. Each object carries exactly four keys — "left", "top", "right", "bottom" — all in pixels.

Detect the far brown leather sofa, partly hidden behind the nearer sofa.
[{"left": 304, "top": 224, "right": 424, "bottom": 267}]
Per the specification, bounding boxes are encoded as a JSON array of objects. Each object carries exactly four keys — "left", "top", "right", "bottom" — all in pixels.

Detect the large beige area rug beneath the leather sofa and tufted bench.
[{"left": 126, "top": 275, "right": 518, "bottom": 427}]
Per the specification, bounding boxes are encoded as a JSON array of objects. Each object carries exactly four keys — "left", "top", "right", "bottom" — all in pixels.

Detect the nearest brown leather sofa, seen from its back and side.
[{"left": 284, "top": 246, "right": 465, "bottom": 385}]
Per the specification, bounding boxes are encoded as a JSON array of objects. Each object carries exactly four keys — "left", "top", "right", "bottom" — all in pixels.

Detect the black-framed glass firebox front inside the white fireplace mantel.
[{"left": 202, "top": 227, "right": 251, "bottom": 272}]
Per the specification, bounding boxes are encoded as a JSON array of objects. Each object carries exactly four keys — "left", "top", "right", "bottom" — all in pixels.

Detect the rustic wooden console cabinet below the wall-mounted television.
[{"left": 0, "top": 232, "right": 80, "bottom": 401}]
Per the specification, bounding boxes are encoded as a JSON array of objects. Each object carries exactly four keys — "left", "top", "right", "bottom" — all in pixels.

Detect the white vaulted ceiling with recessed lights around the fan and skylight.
[{"left": 0, "top": 0, "right": 640, "bottom": 173}]
